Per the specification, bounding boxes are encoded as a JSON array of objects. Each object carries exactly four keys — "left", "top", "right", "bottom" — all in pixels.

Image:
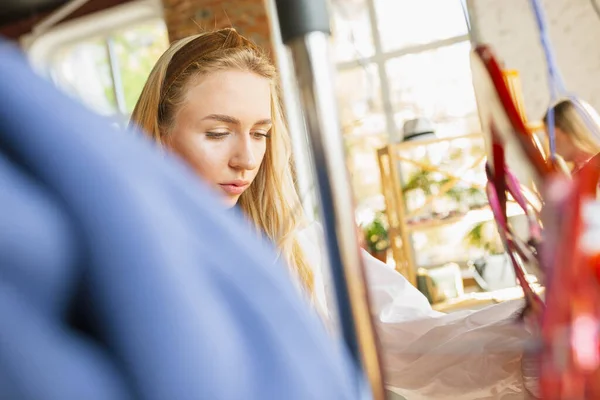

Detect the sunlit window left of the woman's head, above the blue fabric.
[{"left": 38, "top": 19, "right": 169, "bottom": 125}]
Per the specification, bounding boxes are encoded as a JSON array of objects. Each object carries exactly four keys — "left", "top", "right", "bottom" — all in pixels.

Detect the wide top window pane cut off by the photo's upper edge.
[{"left": 373, "top": 0, "right": 467, "bottom": 51}]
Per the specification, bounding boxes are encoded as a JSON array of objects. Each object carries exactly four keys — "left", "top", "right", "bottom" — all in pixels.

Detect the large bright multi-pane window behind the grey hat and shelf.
[{"left": 332, "top": 0, "right": 480, "bottom": 208}]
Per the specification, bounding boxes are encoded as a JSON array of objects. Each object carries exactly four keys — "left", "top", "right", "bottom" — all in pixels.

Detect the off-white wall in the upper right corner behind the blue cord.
[{"left": 467, "top": 0, "right": 600, "bottom": 120}]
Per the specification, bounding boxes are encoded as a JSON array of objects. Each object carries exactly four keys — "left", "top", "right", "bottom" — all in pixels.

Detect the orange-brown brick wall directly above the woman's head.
[{"left": 162, "top": 0, "right": 270, "bottom": 49}]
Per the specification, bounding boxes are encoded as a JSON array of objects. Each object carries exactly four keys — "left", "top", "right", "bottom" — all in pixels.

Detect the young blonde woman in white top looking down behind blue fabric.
[{"left": 132, "top": 29, "right": 528, "bottom": 400}]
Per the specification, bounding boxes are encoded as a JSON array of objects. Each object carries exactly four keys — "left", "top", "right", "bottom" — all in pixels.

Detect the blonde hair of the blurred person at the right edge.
[{"left": 544, "top": 99, "right": 600, "bottom": 155}]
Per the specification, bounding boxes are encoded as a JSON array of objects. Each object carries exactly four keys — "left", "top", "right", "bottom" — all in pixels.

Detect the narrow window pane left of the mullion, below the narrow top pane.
[{"left": 336, "top": 64, "right": 385, "bottom": 136}]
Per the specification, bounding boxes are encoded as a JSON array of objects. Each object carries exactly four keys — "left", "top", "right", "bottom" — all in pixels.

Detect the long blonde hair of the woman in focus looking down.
[{"left": 130, "top": 29, "right": 314, "bottom": 295}]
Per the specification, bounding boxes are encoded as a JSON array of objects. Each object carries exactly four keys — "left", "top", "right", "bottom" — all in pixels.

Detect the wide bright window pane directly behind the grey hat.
[{"left": 386, "top": 42, "right": 480, "bottom": 137}]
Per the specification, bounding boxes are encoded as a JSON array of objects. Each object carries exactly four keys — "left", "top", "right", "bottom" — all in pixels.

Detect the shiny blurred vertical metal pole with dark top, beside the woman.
[{"left": 266, "top": 0, "right": 385, "bottom": 400}]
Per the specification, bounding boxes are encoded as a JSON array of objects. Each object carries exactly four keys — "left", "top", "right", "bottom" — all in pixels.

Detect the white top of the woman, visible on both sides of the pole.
[{"left": 299, "top": 223, "right": 529, "bottom": 400}]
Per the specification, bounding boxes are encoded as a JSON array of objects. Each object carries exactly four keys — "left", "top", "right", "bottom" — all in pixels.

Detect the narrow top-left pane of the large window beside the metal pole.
[{"left": 332, "top": 0, "right": 374, "bottom": 62}]
